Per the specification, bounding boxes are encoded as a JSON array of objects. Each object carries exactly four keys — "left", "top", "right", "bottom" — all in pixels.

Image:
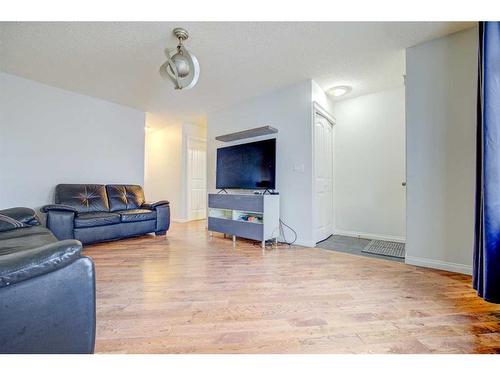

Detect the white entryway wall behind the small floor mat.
[{"left": 334, "top": 87, "right": 405, "bottom": 241}]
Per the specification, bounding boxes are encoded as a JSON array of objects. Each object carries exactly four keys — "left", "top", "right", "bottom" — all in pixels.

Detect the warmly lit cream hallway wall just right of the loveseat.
[{"left": 144, "top": 113, "right": 206, "bottom": 222}]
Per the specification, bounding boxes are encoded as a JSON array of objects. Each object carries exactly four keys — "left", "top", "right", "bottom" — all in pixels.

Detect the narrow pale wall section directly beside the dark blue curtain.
[{"left": 406, "top": 28, "right": 477, "bottom": 273}]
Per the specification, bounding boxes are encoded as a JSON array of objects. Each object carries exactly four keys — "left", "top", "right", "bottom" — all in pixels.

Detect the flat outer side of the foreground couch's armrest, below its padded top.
[{"left": 0, "top": 254, "right": 96, "bottom": 354}]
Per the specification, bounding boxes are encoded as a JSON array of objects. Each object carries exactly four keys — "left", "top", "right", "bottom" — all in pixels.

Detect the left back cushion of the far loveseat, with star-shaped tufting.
[{"left": 55, "top": 184, "right": 109, "bottom": 212}]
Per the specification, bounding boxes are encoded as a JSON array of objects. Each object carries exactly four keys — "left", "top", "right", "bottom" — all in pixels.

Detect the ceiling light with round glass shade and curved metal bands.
[{"left": 160, "top": 27, "right": 200, "bottom": 90}]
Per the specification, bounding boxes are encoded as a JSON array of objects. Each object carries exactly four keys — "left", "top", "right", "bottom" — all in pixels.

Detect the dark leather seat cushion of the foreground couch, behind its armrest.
[{"left": 0, "top": 226, "right": 57, "bottom": 257}]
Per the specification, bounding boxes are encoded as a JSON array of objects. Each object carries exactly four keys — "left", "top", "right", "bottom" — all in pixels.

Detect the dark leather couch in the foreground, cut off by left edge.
[{"left": 0, "top": 207, "right": 95, "bottom": 353}]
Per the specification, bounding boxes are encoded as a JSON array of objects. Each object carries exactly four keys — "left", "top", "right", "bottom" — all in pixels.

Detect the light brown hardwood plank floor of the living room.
[{"left": 84, "top": 221, "right": 500, "bottom": 353}]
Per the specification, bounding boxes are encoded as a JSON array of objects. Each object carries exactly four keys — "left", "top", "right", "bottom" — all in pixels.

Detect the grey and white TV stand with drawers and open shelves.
[{"left": 208, "top": 193, "right": 280, "bottom": 249}]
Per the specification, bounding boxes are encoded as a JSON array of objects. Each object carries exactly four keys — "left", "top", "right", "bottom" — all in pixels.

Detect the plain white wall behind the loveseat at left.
[{"left": 0, "top": 73, "right": 144, "bottom": 208}]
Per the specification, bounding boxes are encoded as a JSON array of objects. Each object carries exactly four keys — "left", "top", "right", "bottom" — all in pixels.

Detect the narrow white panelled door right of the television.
[{"left": 314, "top": 113, "right": 334, "bottom": 242}]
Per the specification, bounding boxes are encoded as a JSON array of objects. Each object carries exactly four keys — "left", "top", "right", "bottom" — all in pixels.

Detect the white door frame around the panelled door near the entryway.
[{"left": 311, "top": 101, "right": 336, "bottom": 246}]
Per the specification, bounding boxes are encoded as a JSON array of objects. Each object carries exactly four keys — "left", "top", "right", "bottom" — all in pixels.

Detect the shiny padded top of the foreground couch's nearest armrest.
[{"left": 0, "top": 240, "right": 82, "bottom": 288}]
